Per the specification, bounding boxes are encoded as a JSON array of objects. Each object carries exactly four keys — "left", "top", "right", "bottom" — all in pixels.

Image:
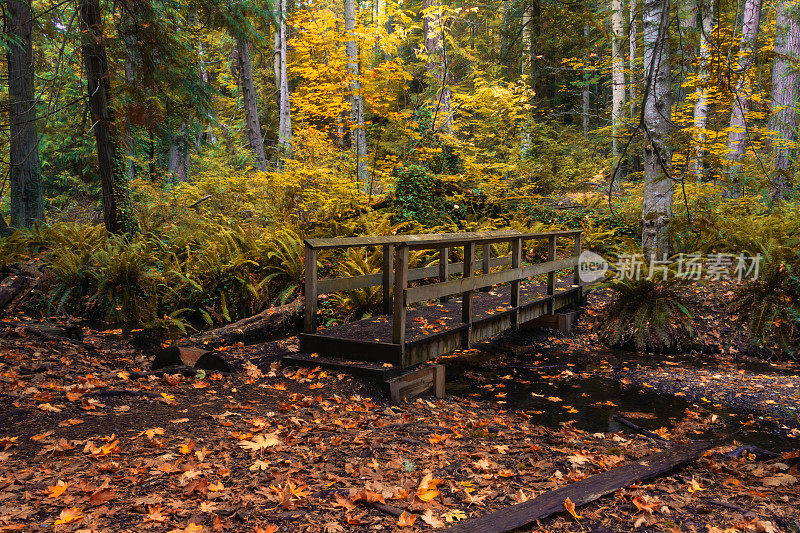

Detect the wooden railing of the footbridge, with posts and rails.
[{"left": 304, "top": 230, "right": 582, "bottom": 346}]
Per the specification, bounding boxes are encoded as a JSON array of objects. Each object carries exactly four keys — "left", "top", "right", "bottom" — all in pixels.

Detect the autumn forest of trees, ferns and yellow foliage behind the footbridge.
[{"left": 0, "top": 0, "right": 800, "bottom": 354}]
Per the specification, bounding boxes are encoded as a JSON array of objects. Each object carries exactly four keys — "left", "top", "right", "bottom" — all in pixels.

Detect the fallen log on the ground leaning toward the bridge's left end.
[{"left": 190, "top": 296, "right": 305, "bottom": 346}]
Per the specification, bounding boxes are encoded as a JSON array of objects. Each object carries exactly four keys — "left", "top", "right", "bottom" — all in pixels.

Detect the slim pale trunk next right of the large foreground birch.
[{"left": 691, "top": 0, "right": 714, "bottom": 182}]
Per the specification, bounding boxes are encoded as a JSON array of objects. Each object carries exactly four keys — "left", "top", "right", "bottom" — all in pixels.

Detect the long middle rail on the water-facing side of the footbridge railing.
[{"left": 406, "top": 257, "right": 577, "bottom": 304}]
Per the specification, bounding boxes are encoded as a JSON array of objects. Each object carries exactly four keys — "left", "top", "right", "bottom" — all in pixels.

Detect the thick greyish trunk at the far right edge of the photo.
[{"left": 769, "top": 0, "right": 800, "bottom": 199}]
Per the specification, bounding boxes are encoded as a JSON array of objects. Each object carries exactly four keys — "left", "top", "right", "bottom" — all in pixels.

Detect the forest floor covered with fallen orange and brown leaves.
[{"left": 0, "top": 282, "right": 800, "bottom": 533}]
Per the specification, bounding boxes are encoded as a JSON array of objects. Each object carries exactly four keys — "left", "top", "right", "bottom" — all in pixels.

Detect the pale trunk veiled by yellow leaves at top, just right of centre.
[{"left": 422, "top": 0, "right": 453, "bottom": 133}]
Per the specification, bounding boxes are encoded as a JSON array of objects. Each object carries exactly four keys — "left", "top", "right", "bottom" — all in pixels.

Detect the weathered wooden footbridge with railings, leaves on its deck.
[{"left": 300, "top": 230, "right": 582, "bottom": 368}]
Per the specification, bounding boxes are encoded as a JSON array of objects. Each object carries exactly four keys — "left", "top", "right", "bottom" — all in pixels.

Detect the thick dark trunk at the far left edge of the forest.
[{"left": 5, "top": 0, "right": 44, "bottom": 228}]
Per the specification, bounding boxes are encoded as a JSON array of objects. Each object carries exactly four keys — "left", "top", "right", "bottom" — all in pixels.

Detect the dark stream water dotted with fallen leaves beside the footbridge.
[{"left": 446, "top": 342, "right": 800, "bottom": 452}]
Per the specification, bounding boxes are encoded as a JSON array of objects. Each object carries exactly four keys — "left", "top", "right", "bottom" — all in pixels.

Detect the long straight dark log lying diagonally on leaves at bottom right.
[{"left": 445, "top": 441, "right": 711, "bottom": 533}]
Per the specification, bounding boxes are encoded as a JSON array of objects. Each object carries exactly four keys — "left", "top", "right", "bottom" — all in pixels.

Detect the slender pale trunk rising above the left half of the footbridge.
[{"left": 344, "top": 0, "right": 369, "bottom": 186}]
